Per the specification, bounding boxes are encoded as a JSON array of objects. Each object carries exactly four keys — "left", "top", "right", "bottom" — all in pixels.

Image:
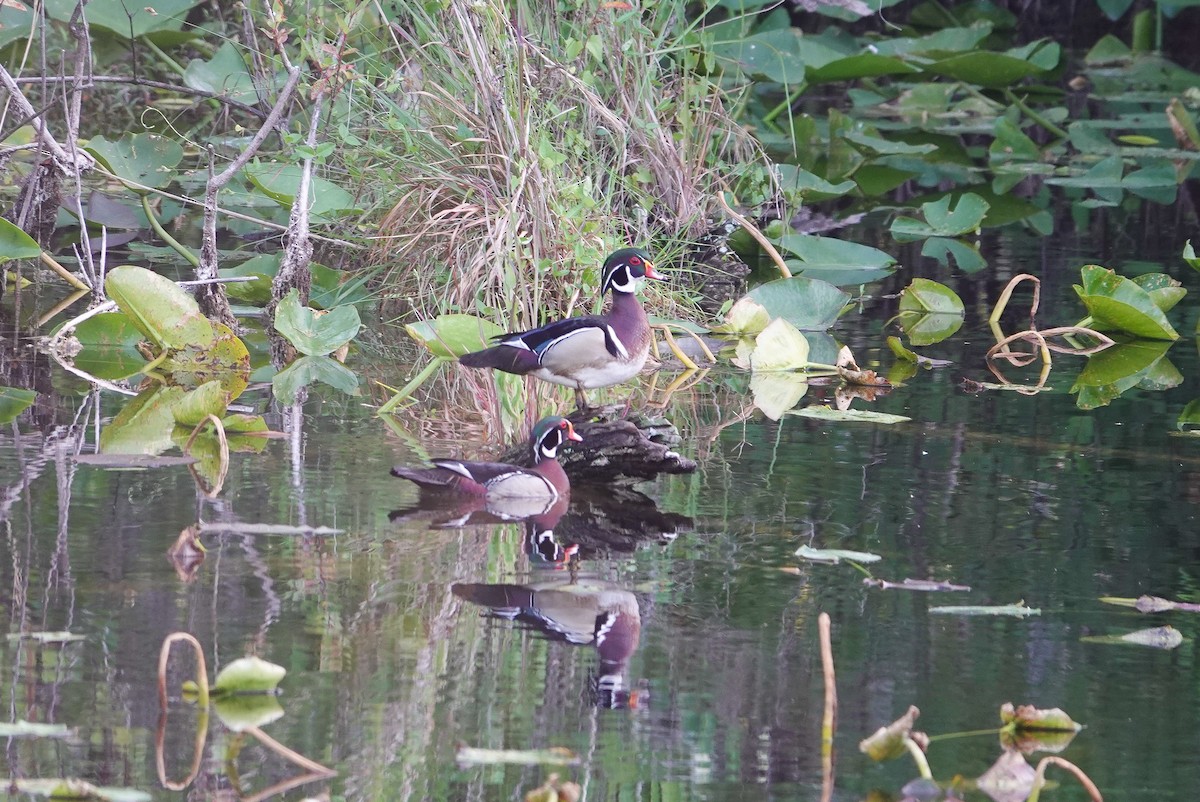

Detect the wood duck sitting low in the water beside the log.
[{"left": 391, "top": 415, "right": 583, "bottom": 503}]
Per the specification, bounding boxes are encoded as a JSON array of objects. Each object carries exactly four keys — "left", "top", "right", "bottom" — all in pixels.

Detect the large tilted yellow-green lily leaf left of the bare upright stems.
[{"left": 104, "top": 264, "right": 215, "bottom": 348}]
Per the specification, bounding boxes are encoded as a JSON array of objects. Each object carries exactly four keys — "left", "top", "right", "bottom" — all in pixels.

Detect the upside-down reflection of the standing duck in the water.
[{"left": 450, "top": 577, "right": 647, "bottom": 708}]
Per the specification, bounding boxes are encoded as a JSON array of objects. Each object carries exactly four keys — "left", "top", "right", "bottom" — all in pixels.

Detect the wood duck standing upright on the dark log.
[{"left": 458, "top": 247, "right": 664, "bottom": 409}]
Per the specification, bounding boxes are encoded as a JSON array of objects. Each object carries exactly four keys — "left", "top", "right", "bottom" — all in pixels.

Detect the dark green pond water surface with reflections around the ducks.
[{"left": 0, "top": 226, "right": 1200, "bottom": 801}]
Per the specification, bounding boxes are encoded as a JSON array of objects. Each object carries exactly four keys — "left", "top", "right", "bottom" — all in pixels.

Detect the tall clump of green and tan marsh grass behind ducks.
[{"left": 360, "top": 0, "right": 761, "bottom": 328}]
